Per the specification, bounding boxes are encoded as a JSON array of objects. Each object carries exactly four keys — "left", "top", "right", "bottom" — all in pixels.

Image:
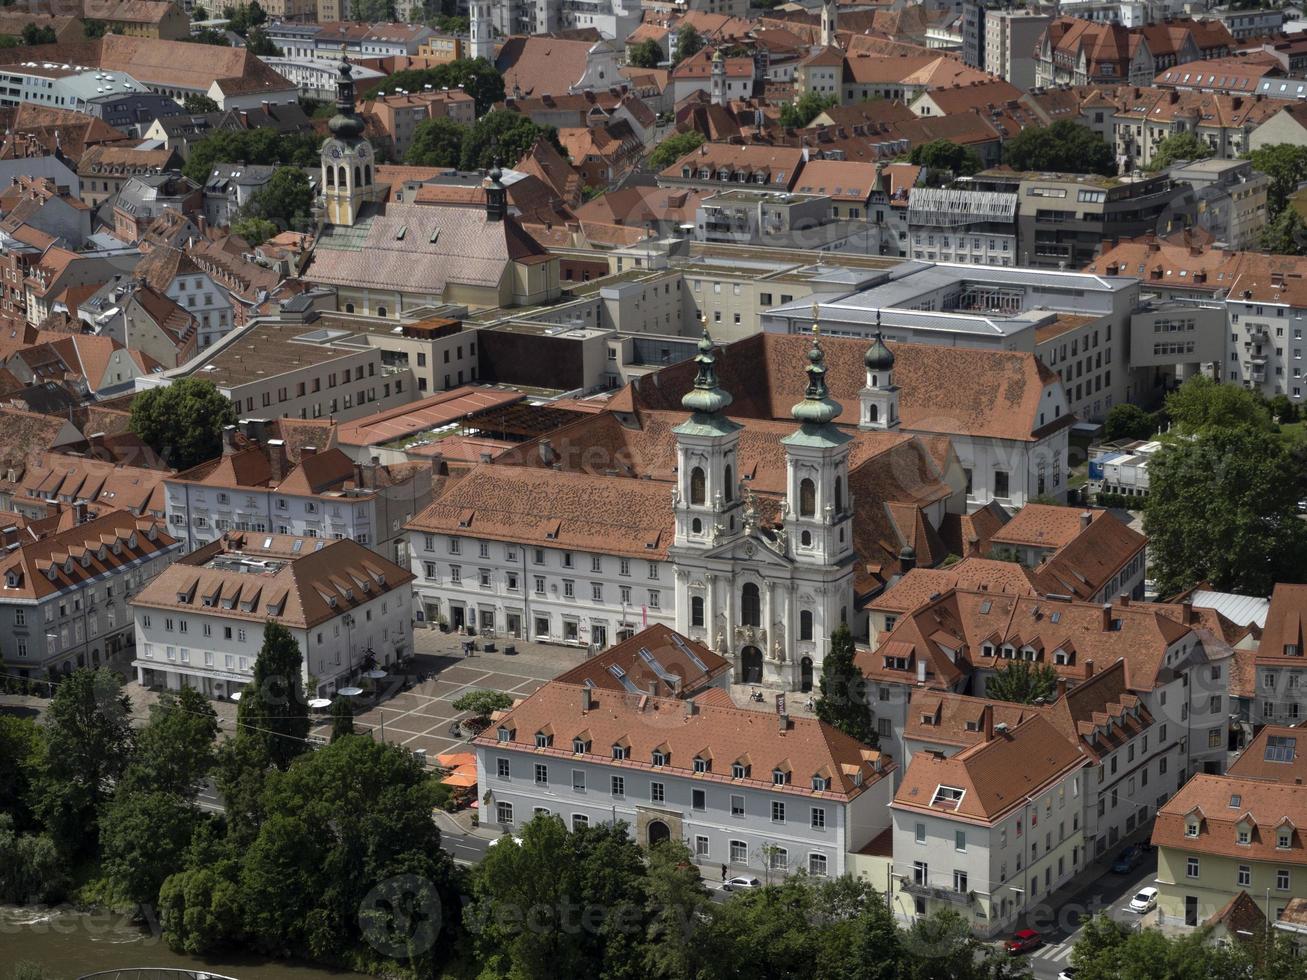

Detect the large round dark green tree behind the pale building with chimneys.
[{"left": 128, "top": 378, "right": 237, "bottom": 469}]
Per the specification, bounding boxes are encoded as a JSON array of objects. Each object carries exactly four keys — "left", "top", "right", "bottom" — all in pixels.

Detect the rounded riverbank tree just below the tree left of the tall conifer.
[{"left": 99, "top": 789, "right": 199, "bottom": 904}]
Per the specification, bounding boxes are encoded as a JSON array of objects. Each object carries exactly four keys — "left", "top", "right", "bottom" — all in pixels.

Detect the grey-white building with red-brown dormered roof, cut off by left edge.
[{"left": 0, "top": 507, "right": 182, "bottom": 679}]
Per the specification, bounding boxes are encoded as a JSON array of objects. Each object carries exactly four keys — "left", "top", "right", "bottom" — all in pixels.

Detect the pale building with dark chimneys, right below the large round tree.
[{"left": 163, "top": 419, "right": 431, "bottom": 566}]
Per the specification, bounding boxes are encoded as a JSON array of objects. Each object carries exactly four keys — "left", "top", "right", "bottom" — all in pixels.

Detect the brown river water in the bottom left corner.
[{"left": 0, "top": 906, "right": 366, "bottom": 980}]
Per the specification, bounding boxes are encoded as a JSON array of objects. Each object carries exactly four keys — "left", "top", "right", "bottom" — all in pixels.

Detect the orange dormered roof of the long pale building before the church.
[{"left": 474, "top": 681, "right": 894, "bottom": 802}]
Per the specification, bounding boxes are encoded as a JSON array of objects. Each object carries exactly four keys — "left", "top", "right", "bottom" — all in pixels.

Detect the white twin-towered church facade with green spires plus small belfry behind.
[{"left": 670, "top": 306, "right": 898, "bottom": 690}]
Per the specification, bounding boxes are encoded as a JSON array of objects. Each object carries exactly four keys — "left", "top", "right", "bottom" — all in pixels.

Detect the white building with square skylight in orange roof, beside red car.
[{"left": 890, "top": 712, "right": 1089, "bottom": 938}]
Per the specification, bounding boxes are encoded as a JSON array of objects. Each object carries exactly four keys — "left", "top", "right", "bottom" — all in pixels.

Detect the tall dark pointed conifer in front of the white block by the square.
[{"left": 237, "top": 619, "right": 310, "bottom": 770}]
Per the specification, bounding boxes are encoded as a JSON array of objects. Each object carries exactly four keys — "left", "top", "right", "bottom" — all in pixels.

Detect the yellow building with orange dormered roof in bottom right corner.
[{"left": 1153, "top": 728, "right": 1307, "bottom": 926}]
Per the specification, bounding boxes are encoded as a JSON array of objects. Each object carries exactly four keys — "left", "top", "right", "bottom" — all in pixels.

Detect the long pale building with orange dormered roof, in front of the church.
[{"left": 473, "top": 655, "right": 893, "bottom": 881}]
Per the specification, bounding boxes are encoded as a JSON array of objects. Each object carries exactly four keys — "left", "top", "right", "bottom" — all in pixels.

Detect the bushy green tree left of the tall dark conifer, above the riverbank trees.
[{"left": 123, "top": 687, "right": 218, "bottom": 801}]
